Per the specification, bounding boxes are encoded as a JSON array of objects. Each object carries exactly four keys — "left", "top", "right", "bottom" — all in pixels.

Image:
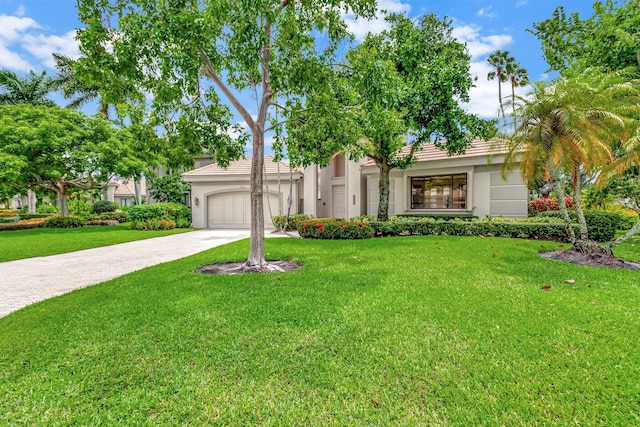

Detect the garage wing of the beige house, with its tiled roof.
[{"left": 182, "top": 156, "right": 302, "bottom": 228}]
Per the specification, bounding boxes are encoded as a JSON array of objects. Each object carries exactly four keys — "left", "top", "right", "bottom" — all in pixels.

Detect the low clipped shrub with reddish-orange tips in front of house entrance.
[{"left": 298, "top": 218, "right": 374, "bottom": 240}]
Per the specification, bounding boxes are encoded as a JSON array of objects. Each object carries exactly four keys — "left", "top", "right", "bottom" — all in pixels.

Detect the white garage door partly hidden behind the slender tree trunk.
[{"left": 207, "top": 191, "right": 278, "bottom": 228}]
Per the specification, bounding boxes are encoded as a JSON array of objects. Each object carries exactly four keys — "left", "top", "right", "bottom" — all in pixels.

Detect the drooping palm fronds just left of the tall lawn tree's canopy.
[{"left": 53, "top": 53, "right": 109, "bottom": 120}]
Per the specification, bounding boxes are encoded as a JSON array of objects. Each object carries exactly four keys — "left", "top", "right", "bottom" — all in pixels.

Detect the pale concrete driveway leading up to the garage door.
[{"left": 0, "top": 230, "right": 260, "bottom": 317}]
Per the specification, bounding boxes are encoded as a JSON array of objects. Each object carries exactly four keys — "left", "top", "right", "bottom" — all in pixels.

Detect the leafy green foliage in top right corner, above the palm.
[{"left": 529, "top": 0, "right": 640, "bottom": 72}]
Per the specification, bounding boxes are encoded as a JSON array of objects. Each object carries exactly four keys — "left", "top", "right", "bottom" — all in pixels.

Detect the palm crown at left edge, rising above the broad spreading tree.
[{"left": 0, "top": 70, "right": 55, "bottom": 106}]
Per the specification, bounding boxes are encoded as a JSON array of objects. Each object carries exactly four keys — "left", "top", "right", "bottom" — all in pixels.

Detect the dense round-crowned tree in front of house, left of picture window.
[{"left": 288, "top": 14, "right": 495, "bottom": 221}]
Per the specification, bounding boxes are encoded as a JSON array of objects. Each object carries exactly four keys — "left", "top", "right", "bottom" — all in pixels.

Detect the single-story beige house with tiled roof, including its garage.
[{"left": 182, "top": 140, "right": 529, "bottom": 228}]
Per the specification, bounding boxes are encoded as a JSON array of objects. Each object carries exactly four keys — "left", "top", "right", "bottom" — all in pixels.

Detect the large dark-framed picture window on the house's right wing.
[{"left": 411, "top": 174, "right": 467, "bottom": 209}]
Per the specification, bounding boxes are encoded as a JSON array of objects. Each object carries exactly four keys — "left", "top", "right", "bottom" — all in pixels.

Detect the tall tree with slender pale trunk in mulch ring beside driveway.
[{"left": 78, "top": 0, "right": 375, "bottom": 270}]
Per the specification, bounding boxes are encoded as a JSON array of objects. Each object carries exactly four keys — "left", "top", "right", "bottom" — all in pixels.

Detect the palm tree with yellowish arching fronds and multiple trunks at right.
[{"left": 503, "top": 70, "right": 638, "bottom": 255}]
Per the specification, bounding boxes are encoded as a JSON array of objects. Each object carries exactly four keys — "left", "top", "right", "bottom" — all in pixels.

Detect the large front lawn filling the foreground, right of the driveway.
[{"left": 0, "top": 236, "right": 640, "bottom": 426}]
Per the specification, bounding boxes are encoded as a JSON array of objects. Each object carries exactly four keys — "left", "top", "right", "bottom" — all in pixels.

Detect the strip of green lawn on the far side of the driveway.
[{"left": 0, "top": 224, "right": 191, "bottom": 262}]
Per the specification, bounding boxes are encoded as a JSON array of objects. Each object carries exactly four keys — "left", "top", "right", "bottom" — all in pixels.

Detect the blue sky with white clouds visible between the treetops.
[{"left": 0, "top": 0, "right": 593, "bottom": 135}]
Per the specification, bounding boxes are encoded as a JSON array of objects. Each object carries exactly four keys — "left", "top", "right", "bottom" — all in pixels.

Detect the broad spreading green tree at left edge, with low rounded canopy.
[{"left": 0, "top": 104, "right": 143, "bottom": 216}]
